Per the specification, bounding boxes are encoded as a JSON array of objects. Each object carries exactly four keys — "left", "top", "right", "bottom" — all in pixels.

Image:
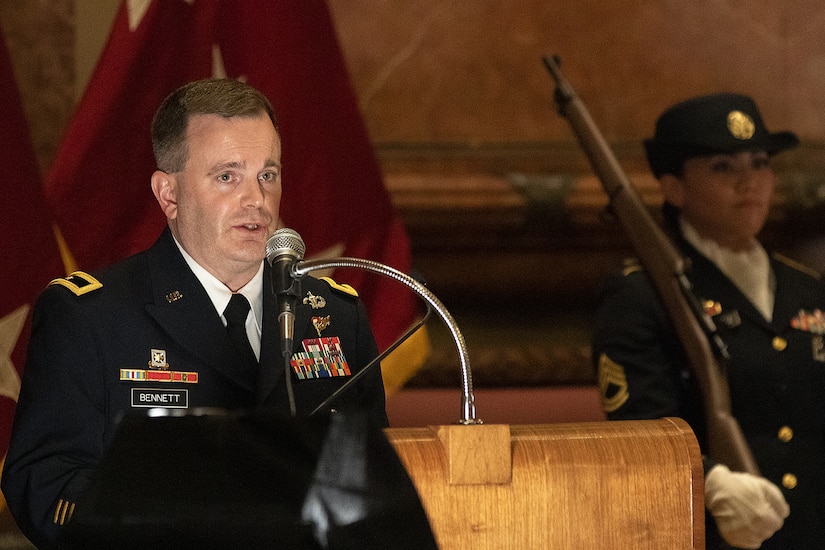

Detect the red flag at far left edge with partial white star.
[{"left": 0, "top": 28, "right": 64, "bottom": 456}]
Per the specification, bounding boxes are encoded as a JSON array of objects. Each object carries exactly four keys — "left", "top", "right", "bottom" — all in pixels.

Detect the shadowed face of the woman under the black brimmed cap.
[{"left": 662, "top": 151, "right": 776, "bottom": 254}]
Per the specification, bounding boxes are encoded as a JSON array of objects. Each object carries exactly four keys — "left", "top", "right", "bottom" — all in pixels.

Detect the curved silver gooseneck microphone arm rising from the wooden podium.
[{"left": 291, "top": 258, "right": 482, "bottom": 424}]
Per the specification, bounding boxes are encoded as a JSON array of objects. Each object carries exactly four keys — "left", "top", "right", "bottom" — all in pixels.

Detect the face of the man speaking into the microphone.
[{"left": 153, "top": 115, "right": 281, "bottom": 287}]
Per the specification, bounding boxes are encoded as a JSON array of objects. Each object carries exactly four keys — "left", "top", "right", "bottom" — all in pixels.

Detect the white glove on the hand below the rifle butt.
[{"left": 705, "top": 464, "right": 790, "bottom": 548}]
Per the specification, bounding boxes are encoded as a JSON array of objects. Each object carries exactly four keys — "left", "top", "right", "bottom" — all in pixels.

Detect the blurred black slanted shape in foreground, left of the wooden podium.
[{"left": 61, "top": 410, "right": 437, "bottom": 550}]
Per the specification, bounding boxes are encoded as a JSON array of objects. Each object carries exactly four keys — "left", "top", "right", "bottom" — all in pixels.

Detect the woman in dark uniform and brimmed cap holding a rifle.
[{"left": 593, "top": 94, "right": 825, "bottom": 550}]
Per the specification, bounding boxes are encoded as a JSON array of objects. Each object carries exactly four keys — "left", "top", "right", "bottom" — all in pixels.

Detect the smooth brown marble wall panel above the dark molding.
[{"left": 329, "top": 0, "right": 825, "bottom": 145}]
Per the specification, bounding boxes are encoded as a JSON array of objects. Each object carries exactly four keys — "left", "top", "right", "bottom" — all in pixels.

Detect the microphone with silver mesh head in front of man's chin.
[{"left": 266, "top": 227, "right": 306, "bottom": 357}]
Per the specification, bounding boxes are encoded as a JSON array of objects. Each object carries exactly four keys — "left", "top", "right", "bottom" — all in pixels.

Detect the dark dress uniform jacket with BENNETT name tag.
[{"left": 2, "top": 229, "right": 387, "bottom": 548}]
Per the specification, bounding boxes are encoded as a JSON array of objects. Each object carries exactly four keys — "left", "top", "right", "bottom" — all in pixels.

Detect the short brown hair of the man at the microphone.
[{"left": 152, "top": 78, "right": 278, "bottom": 174}]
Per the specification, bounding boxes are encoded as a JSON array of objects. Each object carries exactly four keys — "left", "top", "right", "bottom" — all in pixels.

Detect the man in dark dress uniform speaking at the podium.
[{"left": 2, "top": 79, "right": 387, "bottom": 548}]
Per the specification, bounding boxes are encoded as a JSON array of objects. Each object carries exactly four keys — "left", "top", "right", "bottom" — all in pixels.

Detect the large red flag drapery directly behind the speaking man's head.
[{"left": 46, "top": 0, "right": 426, "bottom": 392}]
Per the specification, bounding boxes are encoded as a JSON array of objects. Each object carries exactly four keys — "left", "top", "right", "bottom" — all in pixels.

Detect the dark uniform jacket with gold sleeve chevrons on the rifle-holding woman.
[{"left": 593, "top": 240, "right": 825, "bottom": 550}]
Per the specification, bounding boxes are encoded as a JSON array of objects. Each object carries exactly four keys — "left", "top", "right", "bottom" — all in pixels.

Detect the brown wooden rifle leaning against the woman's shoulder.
[{"left": 544, "top": 56, "right": 759, "bottom": 475}]
